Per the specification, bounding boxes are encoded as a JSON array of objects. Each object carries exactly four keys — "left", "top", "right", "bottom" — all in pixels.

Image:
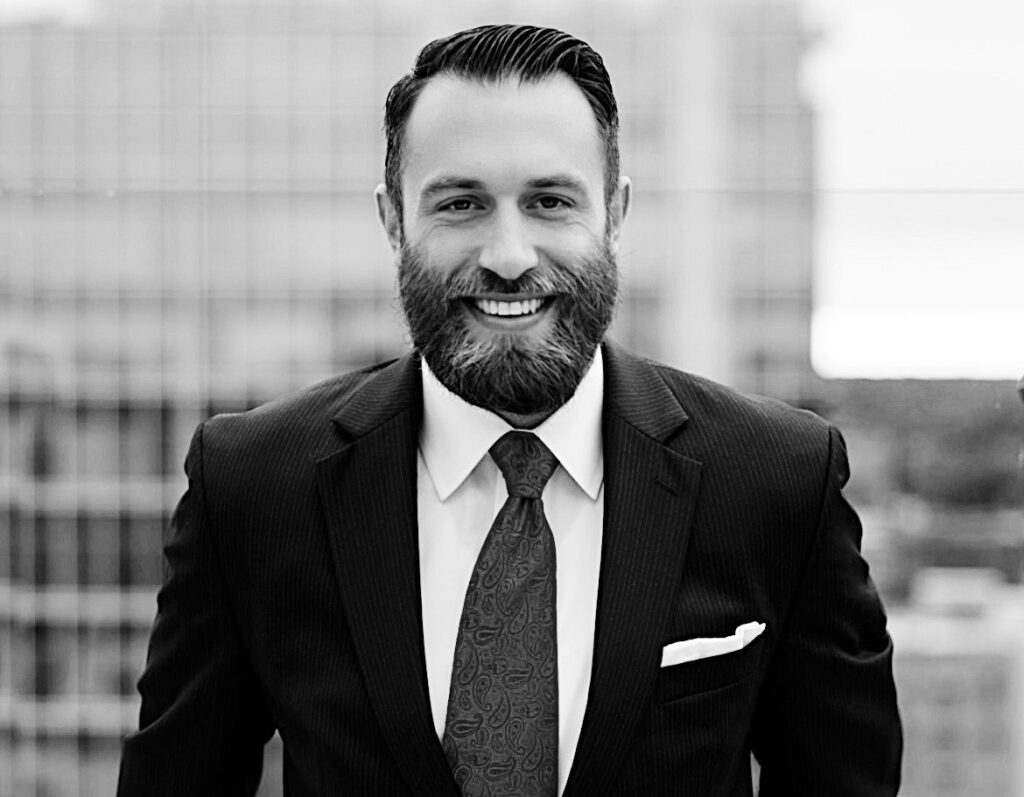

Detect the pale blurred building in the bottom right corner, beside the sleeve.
[{"left": 890, "top": 568, "right": 1024, "bottom": 797}]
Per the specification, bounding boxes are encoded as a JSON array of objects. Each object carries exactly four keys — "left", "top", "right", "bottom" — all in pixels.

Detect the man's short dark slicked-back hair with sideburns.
[{"left": 384, "top": 25, "right": 618, "bottom": 221}]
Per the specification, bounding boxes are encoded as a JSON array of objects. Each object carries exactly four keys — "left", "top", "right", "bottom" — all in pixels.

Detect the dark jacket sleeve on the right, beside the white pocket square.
[{"left": 752, "top": 428, "right": 902, "bottom": 786}]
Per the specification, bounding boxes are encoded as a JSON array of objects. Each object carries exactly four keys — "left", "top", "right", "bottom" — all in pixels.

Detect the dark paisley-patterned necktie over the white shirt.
[{"left": 441, "top": 431, "right": 558, "bottom": 797}]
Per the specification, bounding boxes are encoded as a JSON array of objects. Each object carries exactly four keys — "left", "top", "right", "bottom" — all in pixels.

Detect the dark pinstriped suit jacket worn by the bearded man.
[{"left": 119, "top": 345, "right": 901, "bottom": 797}]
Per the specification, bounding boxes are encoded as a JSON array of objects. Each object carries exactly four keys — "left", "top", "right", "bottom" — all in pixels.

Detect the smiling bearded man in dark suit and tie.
[{"left": 120, "top": 26, "right": 901, "bottom": 797}]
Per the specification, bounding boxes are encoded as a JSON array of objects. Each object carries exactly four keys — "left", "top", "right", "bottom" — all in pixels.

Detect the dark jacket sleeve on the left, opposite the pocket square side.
[{"left": 118, "top": 425, "right": 273, "bottom": 797}]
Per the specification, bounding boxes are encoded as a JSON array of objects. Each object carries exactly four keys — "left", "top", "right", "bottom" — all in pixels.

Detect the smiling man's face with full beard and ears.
[{"left": 378, "top": 76, "right": 629, "bottom": 416}]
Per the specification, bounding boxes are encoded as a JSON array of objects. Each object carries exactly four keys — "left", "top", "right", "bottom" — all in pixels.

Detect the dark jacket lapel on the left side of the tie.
[{"left": 317, "top": 355, "right": 457, "bottom": 795}]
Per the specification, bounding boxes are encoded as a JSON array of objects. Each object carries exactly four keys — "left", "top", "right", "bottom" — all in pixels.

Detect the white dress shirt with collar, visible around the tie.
[{"left": 417, "top": 349, "right": 604, "bottom": 794}]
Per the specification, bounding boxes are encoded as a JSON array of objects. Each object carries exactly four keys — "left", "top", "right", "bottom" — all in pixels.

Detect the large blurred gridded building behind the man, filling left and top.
[{"left": 0, "top": 0, "right": 817, "bottom": 797}]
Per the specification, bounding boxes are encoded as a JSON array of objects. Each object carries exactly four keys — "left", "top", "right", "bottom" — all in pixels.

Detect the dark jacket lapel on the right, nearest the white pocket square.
[{"left": 565, "top": 345, "right": 700, "bottom": 797}]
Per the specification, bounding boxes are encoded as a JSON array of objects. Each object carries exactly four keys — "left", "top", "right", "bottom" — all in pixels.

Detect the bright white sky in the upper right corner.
[{"left": 804, "top": 0, "right": 1024, "bottom": 379}]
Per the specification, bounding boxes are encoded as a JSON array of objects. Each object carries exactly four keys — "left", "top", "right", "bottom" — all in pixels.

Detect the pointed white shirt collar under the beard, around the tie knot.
[{"left": 420, "top": 346, "right": 604, "bottom": 501}]
